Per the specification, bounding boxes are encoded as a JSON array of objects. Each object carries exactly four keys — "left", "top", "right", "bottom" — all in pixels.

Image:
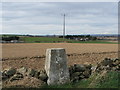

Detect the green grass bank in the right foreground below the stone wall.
[{"left": 42, "top": 71, "right": 120, "bottom": 88}]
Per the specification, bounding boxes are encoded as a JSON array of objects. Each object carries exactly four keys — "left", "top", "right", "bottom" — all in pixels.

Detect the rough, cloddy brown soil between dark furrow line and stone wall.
[{"left": 2, "top": 52, "right": 118, "bottom": 70}]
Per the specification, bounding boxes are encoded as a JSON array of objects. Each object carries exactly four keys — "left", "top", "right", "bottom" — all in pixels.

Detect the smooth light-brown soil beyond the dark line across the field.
[{"left": 2, "top": 43, "right": 118, "bottom": 58}]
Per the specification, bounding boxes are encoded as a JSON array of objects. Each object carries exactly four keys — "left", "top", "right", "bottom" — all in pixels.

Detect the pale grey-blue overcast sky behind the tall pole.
[{"left": 2, "top": 2, "right": 118, "bottom": 35}]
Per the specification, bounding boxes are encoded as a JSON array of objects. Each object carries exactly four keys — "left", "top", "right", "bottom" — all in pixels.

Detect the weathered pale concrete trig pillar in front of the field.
[{"left": 45, "top": 48, "right": 70, "bottom": 85}]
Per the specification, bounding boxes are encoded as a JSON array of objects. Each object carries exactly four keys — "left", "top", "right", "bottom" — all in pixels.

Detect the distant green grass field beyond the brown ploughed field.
[{"left": 20, "top": 37, "right": 118, "bottom": 44}]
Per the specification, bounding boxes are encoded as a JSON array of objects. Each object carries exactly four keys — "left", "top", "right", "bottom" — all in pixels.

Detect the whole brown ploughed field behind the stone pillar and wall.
[{"left": 2, "top": 43, "right": 118, "bottom": 69}]
